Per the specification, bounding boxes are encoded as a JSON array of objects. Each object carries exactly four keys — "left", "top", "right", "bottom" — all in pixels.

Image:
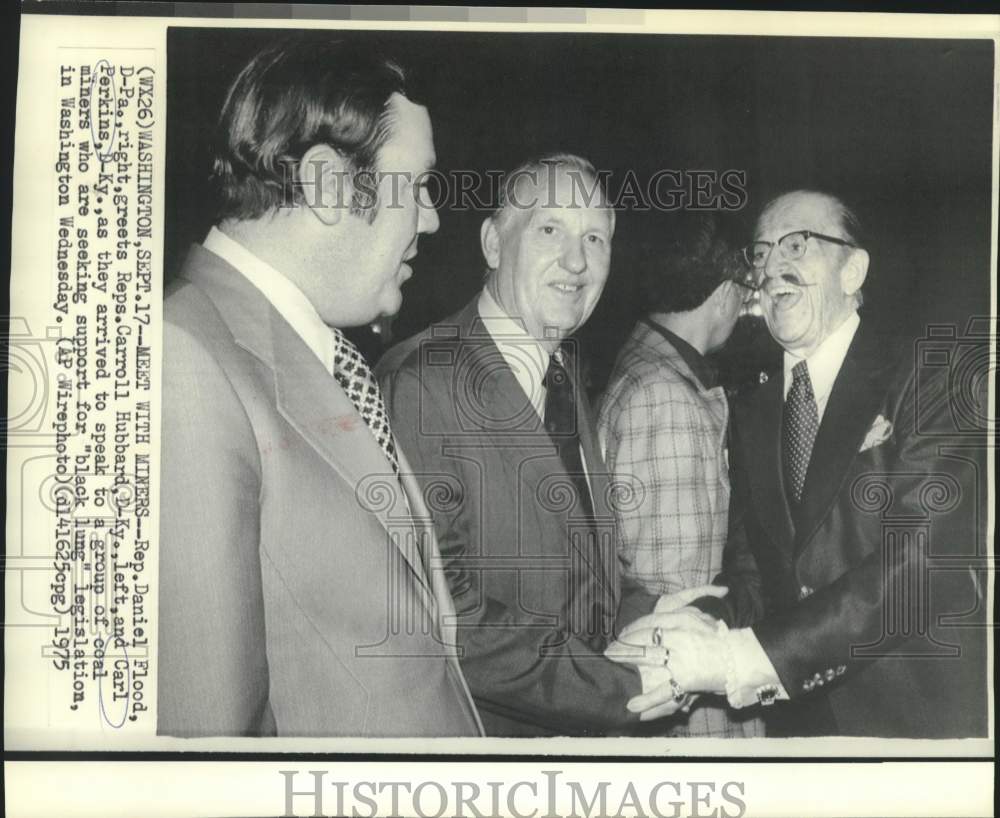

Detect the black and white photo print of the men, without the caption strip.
[{"left": 158, "top": 28, "right": 994, "bottom": 738}]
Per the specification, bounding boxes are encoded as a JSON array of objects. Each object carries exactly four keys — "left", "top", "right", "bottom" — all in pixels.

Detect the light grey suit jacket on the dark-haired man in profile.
[{"left": 157, "top": 246, "right": 481, "bottom": 736}]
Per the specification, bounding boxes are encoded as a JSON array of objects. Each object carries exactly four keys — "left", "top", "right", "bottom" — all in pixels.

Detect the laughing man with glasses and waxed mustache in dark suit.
[{"left": 611, "top": 191, "right": 987, "bottom": 738}]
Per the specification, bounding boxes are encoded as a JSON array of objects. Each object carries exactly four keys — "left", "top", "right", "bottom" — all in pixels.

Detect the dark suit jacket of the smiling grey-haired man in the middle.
[{"left": 377, "top": 298, "right": 655, "bottom": 735}]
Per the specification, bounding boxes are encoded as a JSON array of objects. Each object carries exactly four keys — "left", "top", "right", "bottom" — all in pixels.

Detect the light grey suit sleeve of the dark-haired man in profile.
[{"left": 157, "top": 324, "right": 273, "bottom": 736}]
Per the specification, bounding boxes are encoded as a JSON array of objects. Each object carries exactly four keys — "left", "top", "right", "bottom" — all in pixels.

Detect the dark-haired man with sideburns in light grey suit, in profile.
[{"left": 157, "top": 38, "right": 481, "bottom": 736}]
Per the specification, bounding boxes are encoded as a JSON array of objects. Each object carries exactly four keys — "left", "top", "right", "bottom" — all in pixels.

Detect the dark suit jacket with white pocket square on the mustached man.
[{"left": 721, "top": 320, "right": 986, "bottom": 738}]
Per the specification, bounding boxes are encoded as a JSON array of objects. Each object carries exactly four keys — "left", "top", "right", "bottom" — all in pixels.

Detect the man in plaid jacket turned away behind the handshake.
[{"left": 598, "top": 214, "right": 763, "bottom": 737}]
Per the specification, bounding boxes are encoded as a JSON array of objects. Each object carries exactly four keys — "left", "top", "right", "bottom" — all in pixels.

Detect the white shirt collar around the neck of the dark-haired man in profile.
[{"left": 203, "top": 227, "right": 334, "bottom": 373}]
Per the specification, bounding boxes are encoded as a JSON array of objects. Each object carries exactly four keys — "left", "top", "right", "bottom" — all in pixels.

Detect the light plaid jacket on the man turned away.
[{"left": 598, "top": 320, "right": 763, "bottom": 738}]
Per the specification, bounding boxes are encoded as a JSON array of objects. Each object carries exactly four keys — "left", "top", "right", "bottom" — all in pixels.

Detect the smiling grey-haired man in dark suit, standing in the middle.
[{"left": 378, "top": 154, "right": 720, "bottom": 736}]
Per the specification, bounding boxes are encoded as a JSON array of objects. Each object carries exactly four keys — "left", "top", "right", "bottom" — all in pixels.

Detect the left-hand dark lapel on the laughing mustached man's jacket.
[{"left": 737, "top": 377, "right": 794, "bottom": 553}]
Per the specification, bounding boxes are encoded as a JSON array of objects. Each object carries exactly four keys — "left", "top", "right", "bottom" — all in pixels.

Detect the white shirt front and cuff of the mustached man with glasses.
[{"left": 719, "top": 311, "right": 861, "bottom": 707}]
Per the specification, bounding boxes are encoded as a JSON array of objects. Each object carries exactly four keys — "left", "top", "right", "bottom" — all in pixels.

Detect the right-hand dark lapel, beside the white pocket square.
[{"left": 795, "top": 327, "right": 885, "bottom": 548}]
